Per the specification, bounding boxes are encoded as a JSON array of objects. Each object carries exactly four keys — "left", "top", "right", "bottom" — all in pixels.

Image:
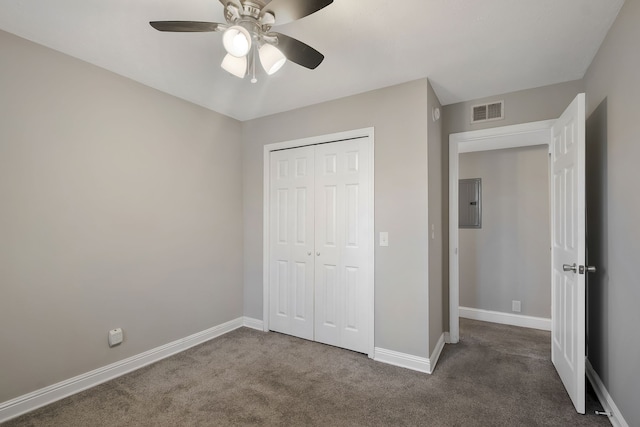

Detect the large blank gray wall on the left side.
[{"left": 0, "top": 32, "right": 243, "bottom": 402}]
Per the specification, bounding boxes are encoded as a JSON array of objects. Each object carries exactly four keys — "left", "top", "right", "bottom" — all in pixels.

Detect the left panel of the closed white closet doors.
[{"left": 269, "top": 147, "right": 315, "bottom": 340}]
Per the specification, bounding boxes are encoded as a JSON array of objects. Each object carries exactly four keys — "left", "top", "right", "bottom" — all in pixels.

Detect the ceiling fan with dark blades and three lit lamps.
[{"left": 149, "top": 0, "right": 333, "bottom": 83}]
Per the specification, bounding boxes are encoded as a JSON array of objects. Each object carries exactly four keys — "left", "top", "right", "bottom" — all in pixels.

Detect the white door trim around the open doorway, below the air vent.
[{"left": 449, "top": 120, "right": 555, "bottom": 343}]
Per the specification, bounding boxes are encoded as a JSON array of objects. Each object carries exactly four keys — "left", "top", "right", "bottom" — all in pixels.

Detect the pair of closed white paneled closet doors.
[{"left": 269, "top": 138, "right": 373, "bottom": 353}]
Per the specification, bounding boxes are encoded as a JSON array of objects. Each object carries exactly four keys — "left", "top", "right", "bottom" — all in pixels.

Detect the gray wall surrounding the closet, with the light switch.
[{"left": 243, "top": 79, "right": 431, "bottom": 357}]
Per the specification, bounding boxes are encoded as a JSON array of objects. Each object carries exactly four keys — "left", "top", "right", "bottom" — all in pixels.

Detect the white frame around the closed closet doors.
[{"left": 262, "top": 127, "right": 375, "bottom": 358}]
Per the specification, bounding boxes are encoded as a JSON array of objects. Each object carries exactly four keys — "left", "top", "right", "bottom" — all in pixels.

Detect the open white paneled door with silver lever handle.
[{"left": 551, "top": 94, "right": 585, "bottom": 414}]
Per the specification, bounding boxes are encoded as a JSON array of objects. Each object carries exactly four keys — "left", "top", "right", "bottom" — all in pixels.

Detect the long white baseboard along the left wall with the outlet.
[{"left": 0, "top": 317, "right": 245, "bottom": 423}]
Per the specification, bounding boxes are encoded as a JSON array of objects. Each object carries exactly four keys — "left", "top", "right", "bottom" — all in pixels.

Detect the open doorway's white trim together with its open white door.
[{"left": 449, "top": 93, "right": 595, "bottom": 414}]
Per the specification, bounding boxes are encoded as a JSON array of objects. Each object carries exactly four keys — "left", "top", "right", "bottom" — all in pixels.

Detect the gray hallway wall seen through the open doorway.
[{"left": 459, "top": 145, "right": 551, "bottom": 318}]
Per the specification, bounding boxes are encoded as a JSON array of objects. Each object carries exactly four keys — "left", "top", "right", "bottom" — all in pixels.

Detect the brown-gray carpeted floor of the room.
[{"left": 3, "top": 319, "right": 610, "bottom": 427}]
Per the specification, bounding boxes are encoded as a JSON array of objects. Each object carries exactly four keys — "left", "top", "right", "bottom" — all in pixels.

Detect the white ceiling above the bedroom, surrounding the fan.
[{"left": 0, "top": 0, "right": 624, "bottom": 120}]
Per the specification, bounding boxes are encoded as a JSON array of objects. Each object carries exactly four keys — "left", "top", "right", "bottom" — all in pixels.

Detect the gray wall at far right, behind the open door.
[{"left": 584, "top": 1, "right": 640, "bottom": 426}]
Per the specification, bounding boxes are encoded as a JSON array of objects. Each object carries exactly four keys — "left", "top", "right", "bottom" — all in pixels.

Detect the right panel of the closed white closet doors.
[{"left": 315, "top": 139, "right": 373, "bottom": 353}]
